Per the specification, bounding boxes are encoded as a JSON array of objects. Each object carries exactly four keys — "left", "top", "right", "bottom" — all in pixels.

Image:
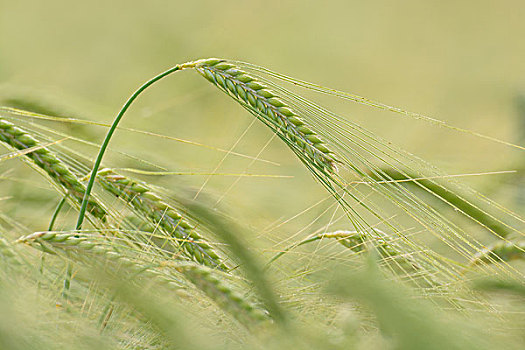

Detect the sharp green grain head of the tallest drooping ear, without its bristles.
[{"left": 189, "top": 58, "right": 337, "bottom": 172}]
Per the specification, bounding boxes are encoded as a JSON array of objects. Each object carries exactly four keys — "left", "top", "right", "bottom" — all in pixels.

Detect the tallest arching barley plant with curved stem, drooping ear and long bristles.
[{"left": 63, "top": 59, "right": 520, "bottom": 300}]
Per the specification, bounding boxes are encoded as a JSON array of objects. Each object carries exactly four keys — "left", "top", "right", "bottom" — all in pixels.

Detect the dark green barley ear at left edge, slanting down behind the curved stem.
[{"left": 0, "top": 119, "right": 107, "bottom": 222}]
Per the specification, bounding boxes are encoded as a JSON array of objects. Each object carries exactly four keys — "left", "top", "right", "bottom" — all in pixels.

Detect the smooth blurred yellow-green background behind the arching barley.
[{"left": 0, "top": 0, "right": 525, "bottom": 243}]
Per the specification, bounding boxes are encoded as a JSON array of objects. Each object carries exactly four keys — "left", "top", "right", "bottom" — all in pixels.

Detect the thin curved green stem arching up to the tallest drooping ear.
[{"left": 76, "top": 65, "right": 183, "bottom": 230}]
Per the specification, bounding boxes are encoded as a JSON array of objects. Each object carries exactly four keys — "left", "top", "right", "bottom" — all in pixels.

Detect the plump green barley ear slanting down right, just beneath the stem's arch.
[{"left": 97, "top": 169, "right": 228, "bottom": 271}]
